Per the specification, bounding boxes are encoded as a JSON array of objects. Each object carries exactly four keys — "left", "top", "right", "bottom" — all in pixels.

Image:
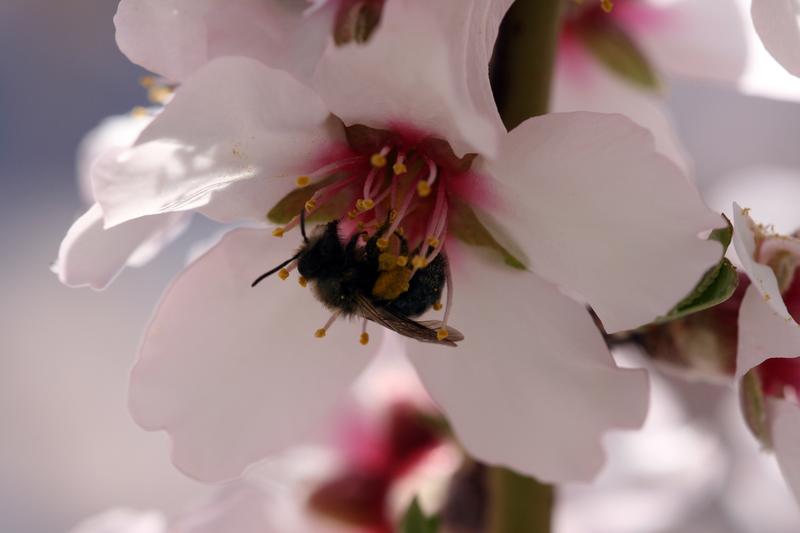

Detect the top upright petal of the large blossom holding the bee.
[{"left": 314, "top": 0, "right": 499, "bottom": 155}]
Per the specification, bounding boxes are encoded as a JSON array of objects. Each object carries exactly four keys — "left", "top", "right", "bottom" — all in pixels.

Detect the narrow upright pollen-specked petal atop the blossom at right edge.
[{"left": 733, "top": 203, "right": 793, "bottom": 318}]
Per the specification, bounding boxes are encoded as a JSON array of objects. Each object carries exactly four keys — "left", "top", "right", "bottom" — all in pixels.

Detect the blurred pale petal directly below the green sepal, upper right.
[{"left": 551, "top": 50, "right": 691, "bottom": 170}]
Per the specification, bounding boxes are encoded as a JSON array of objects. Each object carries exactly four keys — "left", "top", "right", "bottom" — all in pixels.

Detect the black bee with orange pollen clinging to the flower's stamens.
[{"left": 251, "top": 211, "right": 464, "bottom": 346}]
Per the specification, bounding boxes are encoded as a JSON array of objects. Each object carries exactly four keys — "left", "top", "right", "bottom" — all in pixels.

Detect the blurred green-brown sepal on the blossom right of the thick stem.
[{"left": 580, "top": 17, "right": 660, "bottom": 91}]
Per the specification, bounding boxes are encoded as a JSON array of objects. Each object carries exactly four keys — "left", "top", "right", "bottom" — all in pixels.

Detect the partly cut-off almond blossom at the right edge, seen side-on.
[{"left": 733, "top": 204, "right": 800, "bottom": 498}]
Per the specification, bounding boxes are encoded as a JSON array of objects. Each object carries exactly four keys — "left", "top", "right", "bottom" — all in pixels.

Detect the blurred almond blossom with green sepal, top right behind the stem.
[{"left": 553, "top": 0, "right": 800, "bottom": 168}]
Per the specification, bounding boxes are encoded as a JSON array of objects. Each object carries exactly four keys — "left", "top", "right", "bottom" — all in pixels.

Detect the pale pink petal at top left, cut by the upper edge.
[{"left": 114, "top": 0, "right": 334, "bottom": 81}]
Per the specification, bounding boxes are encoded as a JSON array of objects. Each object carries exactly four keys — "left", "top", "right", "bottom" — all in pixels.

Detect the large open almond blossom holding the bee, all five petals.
[{"left": 84, "top": 0, "right": 721, "bottom": 481}]
